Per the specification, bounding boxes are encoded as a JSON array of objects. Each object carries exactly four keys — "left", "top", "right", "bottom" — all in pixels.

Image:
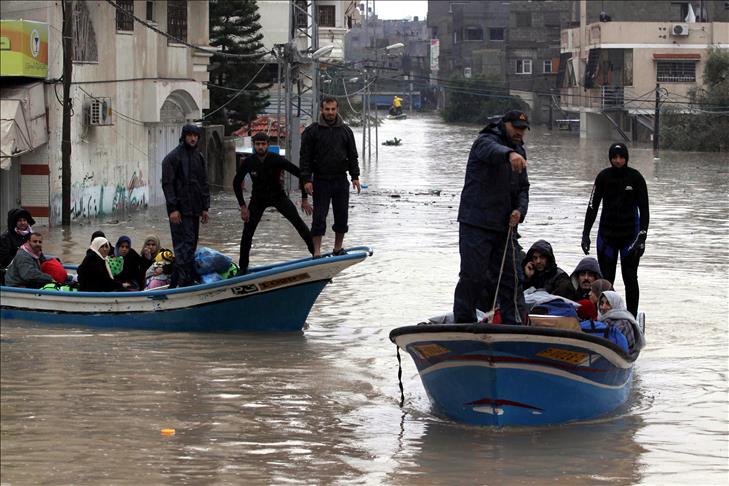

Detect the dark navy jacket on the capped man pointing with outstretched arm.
[{"left": 458, "top": 121, "right": 529, "bottom": 233}]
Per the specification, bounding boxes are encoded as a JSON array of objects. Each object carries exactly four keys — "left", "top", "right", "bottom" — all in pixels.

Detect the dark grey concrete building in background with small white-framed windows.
[{"left": 428, "top": 0, "right": 574, "bottom": 122}]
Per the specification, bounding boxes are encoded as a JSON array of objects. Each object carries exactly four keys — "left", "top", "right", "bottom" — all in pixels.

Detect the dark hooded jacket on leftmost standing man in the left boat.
[{"left": 162, "top": 125, "right": 210, "bottom": 217}]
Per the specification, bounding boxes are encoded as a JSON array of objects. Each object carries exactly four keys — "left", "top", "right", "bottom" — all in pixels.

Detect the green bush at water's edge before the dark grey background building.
[{"left": 441, "top": 77, "right": 526, "bottom": 124}]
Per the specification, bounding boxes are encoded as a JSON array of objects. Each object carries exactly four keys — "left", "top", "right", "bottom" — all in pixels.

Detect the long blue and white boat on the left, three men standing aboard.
[{"left": 0, "top": 247, "right": 372, "bottom": 332}]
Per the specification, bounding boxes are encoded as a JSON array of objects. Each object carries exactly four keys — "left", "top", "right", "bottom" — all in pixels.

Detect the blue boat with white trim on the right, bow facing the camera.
[{"left": 390, "top": 316, "right": 643, "bottom": 426}]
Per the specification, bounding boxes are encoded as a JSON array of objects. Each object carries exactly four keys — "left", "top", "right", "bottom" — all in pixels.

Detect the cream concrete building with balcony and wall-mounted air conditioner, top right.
[{"left": 558, "top": 0, "right": 729, "bottom": 141}]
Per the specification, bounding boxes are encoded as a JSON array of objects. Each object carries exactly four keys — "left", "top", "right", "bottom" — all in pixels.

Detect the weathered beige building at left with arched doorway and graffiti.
[{"left": 0, "top": 0, "right": 211, "bottom": 224}]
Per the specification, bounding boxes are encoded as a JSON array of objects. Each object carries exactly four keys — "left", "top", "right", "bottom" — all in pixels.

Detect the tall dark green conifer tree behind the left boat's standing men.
[{"left": 208, "top": 0, "right": 270, "bottom": 135}]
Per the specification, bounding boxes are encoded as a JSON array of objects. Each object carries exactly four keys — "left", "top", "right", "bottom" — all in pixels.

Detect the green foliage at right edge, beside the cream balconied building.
[{"left": 661, "top": 49, "right": 729, "bottom": 152}]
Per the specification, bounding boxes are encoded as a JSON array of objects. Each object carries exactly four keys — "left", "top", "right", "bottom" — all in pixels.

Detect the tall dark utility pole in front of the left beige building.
[{"left": 61, "top": 0, "right": 73, "bottom": 226}]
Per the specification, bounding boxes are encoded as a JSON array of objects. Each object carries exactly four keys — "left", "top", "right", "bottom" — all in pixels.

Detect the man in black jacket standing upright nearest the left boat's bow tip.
[{"left": 300, "top": 97, "right": 361, "bottom": 258}]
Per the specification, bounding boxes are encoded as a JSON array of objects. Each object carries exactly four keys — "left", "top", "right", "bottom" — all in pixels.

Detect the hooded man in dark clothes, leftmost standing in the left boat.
[{"left": 162, "top": 124, "right": 210, "bottom": 288}]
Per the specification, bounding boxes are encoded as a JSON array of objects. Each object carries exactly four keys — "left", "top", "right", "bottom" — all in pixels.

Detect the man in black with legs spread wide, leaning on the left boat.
[{"left": 233, "top": 132, "right": 314, "bottom": 275}]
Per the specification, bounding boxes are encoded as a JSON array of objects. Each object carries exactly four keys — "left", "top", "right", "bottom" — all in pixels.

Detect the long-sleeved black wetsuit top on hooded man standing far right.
[{"left": 583, "top": 155, "right": 650, "bottom": 243}]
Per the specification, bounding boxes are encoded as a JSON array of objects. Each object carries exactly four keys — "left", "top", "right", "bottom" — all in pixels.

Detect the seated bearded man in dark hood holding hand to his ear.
[{"left": 522, "top": 240, "right": 577, "bottom": 300}]
